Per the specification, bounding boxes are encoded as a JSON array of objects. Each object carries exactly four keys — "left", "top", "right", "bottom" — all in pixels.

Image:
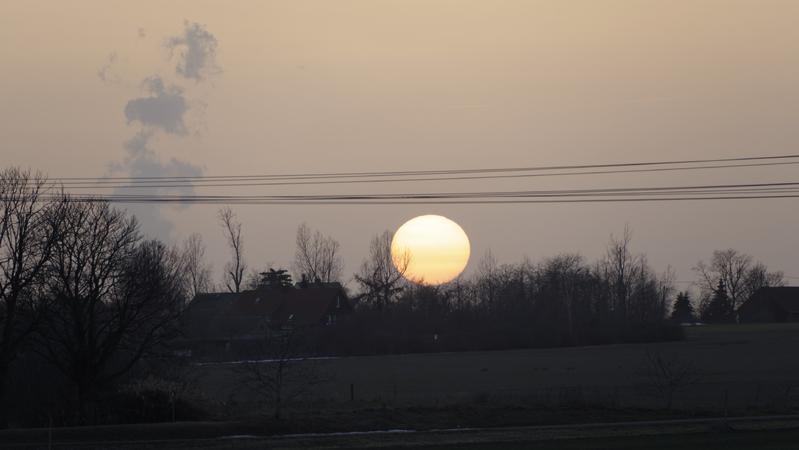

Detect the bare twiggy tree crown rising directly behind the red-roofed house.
[{"left": 293, "top": 223, "right": 344, "bottom": 283}]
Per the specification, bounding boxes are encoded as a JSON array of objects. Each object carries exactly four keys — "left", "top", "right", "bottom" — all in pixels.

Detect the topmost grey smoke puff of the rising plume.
[{"left": 166, "top": 21, "right": 220, "bottom": 81}]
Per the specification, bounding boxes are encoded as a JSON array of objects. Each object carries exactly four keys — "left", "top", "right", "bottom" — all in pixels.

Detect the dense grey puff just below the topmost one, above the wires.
[{"left": 125, "top": 76, "right": 189, "bottom": 136}]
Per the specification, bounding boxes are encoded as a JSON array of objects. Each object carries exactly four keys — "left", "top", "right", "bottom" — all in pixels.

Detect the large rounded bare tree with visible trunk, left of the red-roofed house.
[{"left": 40, "top": 202, "right": 186, "bottom": 419}]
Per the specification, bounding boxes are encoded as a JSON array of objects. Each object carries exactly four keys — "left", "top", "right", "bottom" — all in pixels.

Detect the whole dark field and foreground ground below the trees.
[{"left": 0, "top": 324, "right": 799, "bottom": 450}]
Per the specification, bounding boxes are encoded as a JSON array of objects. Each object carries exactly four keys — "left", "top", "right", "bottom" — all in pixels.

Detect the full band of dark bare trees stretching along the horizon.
[{"left": 0, "top": 168, "right": 783, "bottom": 425}]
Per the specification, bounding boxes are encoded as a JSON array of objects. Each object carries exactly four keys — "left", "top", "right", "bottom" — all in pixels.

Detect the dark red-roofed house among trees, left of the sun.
[{"left": 175, "top": 278, "right": 352, "bottom": 359}]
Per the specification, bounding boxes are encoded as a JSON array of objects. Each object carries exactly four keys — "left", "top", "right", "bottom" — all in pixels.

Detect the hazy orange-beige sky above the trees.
[{"left": 0, "top": 0, "right": 799, "bottom": 287}]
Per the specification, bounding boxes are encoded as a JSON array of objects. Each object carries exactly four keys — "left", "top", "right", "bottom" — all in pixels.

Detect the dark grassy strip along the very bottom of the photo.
[{"left": 0, "top": 417, "right": 799, "bottom": 450}]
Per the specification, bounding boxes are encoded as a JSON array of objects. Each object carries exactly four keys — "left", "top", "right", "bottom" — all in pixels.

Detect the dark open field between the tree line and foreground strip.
[{"left": 198, "top": 324, "right": 799, "bottom": 412}]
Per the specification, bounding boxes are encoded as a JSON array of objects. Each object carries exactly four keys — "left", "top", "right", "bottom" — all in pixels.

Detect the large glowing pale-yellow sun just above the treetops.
[{"left": 391, "top": 214, "right": 471, "bottom": 285}]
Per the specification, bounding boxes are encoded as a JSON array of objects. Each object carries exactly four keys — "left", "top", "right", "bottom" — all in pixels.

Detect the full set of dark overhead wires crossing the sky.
[{"left": 34, "top": 154, "right": 799, "bottom": 205}]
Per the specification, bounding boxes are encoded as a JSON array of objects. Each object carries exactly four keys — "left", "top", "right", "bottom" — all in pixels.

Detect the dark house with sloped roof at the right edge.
[{"left": 737, "top": 286, "right": 799, "bottom": 323}]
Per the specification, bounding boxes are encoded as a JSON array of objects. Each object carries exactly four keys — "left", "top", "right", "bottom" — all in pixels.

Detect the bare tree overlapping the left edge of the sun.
[{"left": 355, "top": 231, "right": 410, "bottom": 311}]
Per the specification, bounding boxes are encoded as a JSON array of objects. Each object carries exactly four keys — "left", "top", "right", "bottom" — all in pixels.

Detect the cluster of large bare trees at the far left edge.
[{"left": 0, "top": 169, "right": 190, "bottom": 424}]
